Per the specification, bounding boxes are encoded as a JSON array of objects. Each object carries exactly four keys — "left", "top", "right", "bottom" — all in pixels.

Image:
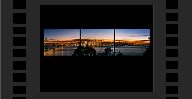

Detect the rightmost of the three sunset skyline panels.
[{"left": 115, "top": 29, "right": 150, "bottom": 56}]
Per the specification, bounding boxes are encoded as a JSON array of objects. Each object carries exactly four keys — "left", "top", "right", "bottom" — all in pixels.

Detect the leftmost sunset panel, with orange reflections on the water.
[{"left": 44, "top": 29, "right": 80, "bottom": 56}]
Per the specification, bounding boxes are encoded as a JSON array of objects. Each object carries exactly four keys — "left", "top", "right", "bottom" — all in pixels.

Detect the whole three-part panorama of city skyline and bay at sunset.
[{"left": 44, "top": 29, "right": 150, "bottom": 56}]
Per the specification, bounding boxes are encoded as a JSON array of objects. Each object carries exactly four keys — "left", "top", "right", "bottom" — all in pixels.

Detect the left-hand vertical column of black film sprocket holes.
[{"left": 12, "top": 0, "right": 27, "bottom": 99}]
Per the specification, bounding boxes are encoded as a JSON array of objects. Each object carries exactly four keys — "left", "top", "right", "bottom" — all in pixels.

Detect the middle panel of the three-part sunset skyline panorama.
[{"left": 81, "top": 29, "right": 114, "bottom": 56}]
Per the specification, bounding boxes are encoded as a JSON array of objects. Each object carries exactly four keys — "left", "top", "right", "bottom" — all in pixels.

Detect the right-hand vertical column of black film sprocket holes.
[{"left": 166, "top": 0, "right": 179, "bottom": 99}]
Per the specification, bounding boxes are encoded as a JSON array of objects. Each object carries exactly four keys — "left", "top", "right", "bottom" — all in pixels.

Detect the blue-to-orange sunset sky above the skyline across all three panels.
[{"left": 44, "top": 29, "right": 150, "bottom": 41}]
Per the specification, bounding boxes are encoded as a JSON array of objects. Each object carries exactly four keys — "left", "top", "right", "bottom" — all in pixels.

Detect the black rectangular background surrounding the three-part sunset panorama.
[{"left": 40, "top": 5, "right": 153, "bottom": 92}]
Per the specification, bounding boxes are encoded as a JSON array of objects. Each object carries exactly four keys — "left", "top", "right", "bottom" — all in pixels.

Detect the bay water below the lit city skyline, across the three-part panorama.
[{"left": 44, "top": 46, "right": 146, "bottom": 56}]
